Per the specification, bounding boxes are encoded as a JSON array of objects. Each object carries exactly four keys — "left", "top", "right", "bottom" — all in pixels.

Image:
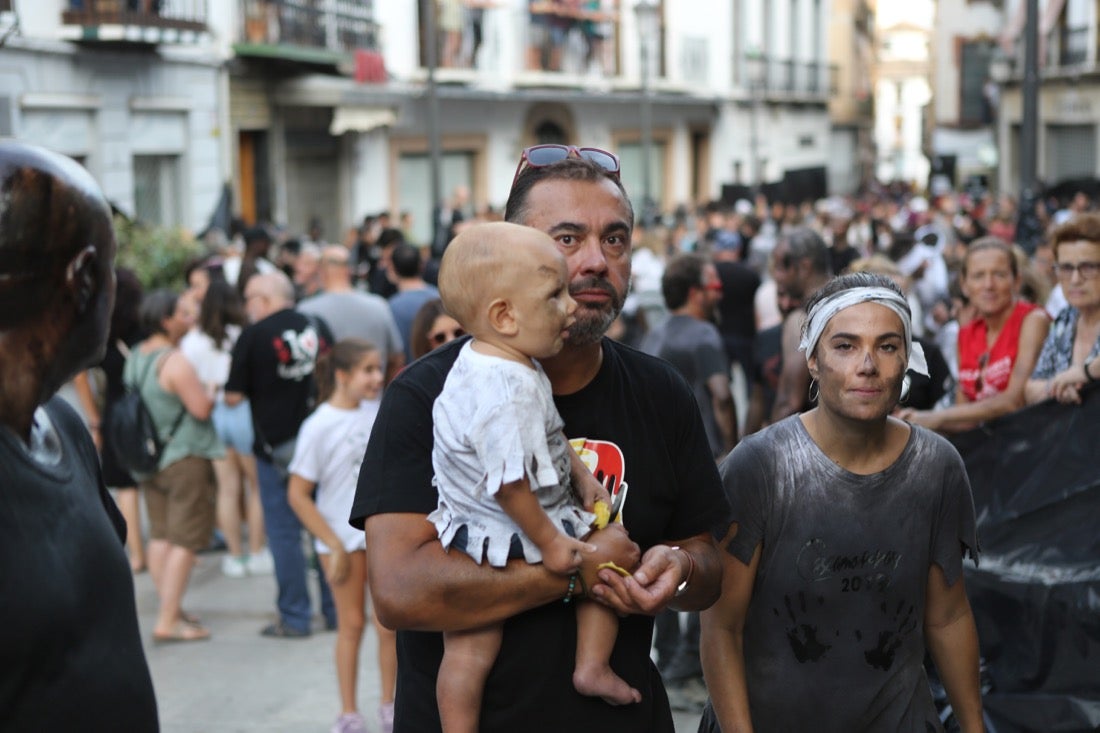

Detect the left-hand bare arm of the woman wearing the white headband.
[{"left": 699, "top": 527, "right": 760, "bottom": 733}]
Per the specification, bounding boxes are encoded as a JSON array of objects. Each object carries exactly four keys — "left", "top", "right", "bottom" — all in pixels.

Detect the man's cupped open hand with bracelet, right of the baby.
[{"left": 591, "top": 545, "right": 688, "bottom": 615}]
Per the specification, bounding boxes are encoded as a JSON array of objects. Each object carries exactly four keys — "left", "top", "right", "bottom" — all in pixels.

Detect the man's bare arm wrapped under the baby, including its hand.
[{"left": 365, "top": 513, "right": 638, "bottom": 631}]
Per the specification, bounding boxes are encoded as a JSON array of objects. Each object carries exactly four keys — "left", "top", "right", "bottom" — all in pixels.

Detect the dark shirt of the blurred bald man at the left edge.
[{"left": 0, "top": 397, "right": 157, "bottom": 733}]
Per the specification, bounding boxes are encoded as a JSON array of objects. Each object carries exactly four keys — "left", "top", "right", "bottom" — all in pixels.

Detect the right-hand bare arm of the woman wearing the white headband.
[{"left": 924, "top": 565, "right": 985, "bottom": 733}]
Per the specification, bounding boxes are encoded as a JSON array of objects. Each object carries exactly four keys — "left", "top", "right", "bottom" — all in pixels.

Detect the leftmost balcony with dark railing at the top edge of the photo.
[{"left": 62, "top": 0, "right": 207, "bottom": 45}]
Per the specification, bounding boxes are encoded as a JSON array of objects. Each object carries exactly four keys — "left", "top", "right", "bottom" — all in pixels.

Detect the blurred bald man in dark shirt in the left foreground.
[{"left": 0, "top": 141, "right": 158, "bottom": 733}]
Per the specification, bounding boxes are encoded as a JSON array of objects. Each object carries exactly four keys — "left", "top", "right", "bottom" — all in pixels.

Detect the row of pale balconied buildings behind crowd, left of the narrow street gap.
[{"left": 0, "top": 0, "right": 840, "bottom": 241}]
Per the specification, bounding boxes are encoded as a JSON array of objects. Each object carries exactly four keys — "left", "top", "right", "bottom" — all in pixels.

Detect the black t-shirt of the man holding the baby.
[{"left": 351, "top": 339, "right": 729, "bottom": 733}]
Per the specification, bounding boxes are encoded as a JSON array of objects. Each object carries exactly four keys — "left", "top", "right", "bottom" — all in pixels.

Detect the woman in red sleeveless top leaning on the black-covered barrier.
[{"left": 900, "top": 237, "right": 1051, "bottom": 433}]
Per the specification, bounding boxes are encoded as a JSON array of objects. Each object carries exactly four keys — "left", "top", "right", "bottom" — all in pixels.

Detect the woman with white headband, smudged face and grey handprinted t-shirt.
[{"left": 700, "top": 273, "right": 982, "bottom": 733}]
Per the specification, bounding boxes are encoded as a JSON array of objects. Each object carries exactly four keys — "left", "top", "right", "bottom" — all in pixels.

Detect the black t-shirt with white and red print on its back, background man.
[{"left": 226, "top": 308, "right": 332, "bottom": 456}]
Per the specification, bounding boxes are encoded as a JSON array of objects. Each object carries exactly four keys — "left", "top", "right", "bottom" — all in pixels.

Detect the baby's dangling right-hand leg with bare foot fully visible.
[{"left": 573, "top": 602, "right": 641, "bottom": 705}]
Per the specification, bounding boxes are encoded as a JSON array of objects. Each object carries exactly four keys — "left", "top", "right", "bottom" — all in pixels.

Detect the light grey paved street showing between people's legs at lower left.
[{"left": 134, "top": 555, "right": 699, "bottom": 733}]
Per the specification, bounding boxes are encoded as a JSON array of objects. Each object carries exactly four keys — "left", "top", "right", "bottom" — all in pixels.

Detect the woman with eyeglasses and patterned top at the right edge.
[{"left": 1025, "top": 214, "right": 1100, "bottom": 404}]
